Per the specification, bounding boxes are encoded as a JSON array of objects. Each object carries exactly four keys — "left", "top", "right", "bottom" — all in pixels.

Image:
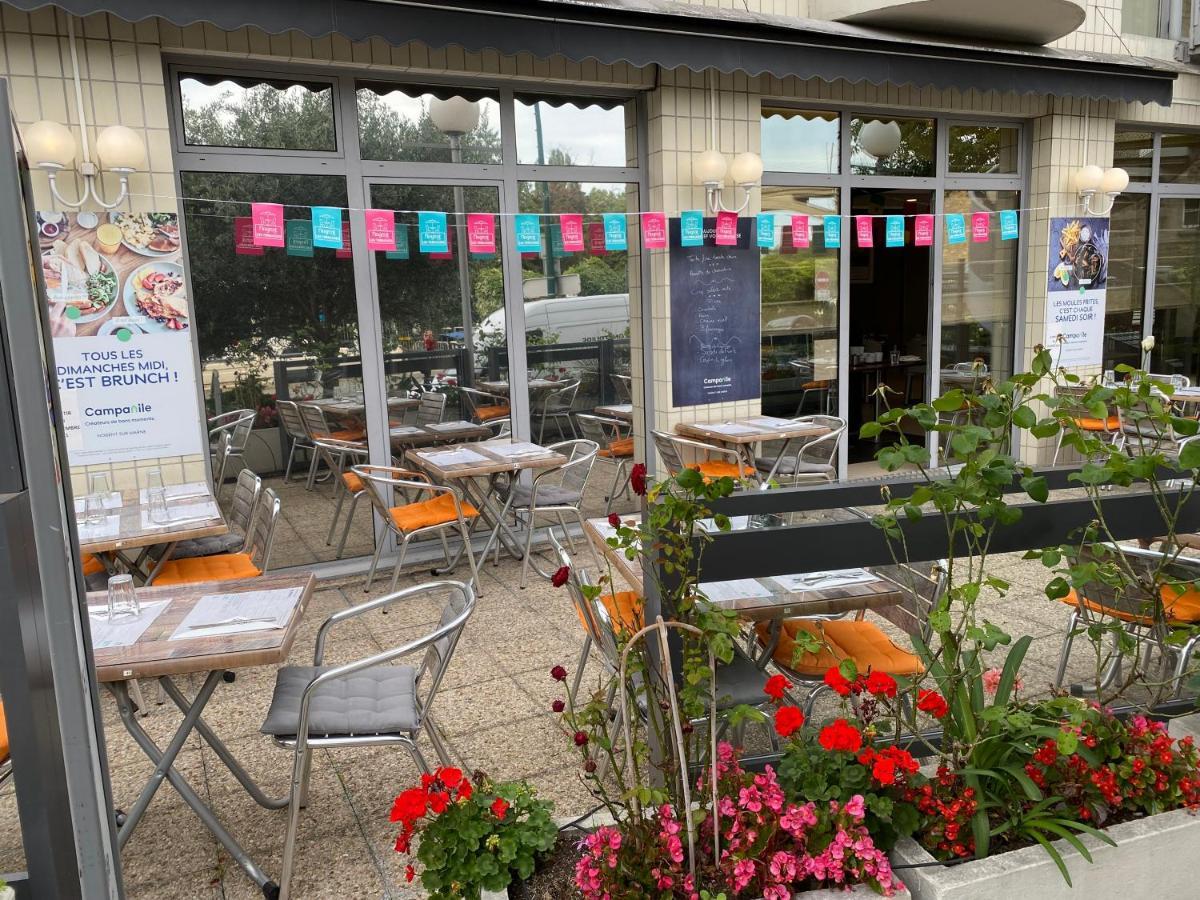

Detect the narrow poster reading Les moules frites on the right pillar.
[{"left": 1043, "top": 216, "right": 1109, "bottom": 368}]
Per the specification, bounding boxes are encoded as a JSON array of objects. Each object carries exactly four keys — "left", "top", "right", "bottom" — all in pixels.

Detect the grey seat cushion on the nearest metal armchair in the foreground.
[{"left": 260, "top": 666, "right": 418, "bottom": 737}]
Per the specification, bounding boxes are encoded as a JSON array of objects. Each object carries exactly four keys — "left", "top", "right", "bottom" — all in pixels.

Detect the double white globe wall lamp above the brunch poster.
[{"left": 23, "top": 119, "right": 146, "bottom": 209}]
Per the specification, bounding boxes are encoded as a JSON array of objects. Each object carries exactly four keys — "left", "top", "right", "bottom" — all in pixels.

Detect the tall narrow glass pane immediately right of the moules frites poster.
[{"left": 1104, "top": 193, "right": 1150, "bottom": 368}]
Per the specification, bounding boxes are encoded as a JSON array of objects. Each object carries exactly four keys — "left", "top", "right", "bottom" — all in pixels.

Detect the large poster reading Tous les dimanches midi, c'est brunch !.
[{"left": 36, "top": 211, "right": 204, "bottom": 466}]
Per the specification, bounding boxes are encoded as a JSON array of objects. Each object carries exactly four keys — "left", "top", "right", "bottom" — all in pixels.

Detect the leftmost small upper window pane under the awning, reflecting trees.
[{"left": 179, "top": 74, "right": 337, "bottom": 150}]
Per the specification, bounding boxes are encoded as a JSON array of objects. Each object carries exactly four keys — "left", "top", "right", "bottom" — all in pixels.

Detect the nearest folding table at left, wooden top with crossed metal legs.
[{"left": 88, "top": 574, "right": 317, "bottom": 898}]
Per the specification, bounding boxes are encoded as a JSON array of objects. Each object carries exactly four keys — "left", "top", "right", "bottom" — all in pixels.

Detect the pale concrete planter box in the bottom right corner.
[{"left": 892, "top": 810, "right": 1200, "bottom": 900}]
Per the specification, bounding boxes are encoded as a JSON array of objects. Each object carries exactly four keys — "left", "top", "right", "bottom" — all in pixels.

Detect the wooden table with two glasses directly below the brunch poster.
[{"left": 76, "top": 481, "right": 229, "bottom": 581}]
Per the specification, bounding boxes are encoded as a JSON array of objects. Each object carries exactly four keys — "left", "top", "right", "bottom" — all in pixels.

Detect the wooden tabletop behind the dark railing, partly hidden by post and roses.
[{"left": 584, "top": 518, "right": 904, "bottom": 622}]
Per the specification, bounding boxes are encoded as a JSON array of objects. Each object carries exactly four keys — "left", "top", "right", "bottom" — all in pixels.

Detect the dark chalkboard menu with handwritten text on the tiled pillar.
[{"left": 671, "top": 218, "right": 762, "bottom": 407}]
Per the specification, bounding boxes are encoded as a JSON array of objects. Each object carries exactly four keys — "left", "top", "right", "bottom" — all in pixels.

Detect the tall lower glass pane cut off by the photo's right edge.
[{"left": 1151, "top": 197, "right": 1200, "bottom": 384}]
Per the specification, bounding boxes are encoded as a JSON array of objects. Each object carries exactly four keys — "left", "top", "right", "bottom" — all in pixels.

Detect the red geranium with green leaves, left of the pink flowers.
[{"left": 391, "top": 767, "right": 558, "bottom": 900}]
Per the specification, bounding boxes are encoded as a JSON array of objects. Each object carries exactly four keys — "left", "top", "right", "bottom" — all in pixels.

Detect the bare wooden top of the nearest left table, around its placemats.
[{"left": 88, "top": 572, "right": 317, "bottom": 682}]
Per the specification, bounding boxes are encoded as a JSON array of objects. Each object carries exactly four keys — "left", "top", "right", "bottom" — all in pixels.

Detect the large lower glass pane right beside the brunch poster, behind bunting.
[{"left": 180, "top": 172, "right": 374, "bottom": 569}]
